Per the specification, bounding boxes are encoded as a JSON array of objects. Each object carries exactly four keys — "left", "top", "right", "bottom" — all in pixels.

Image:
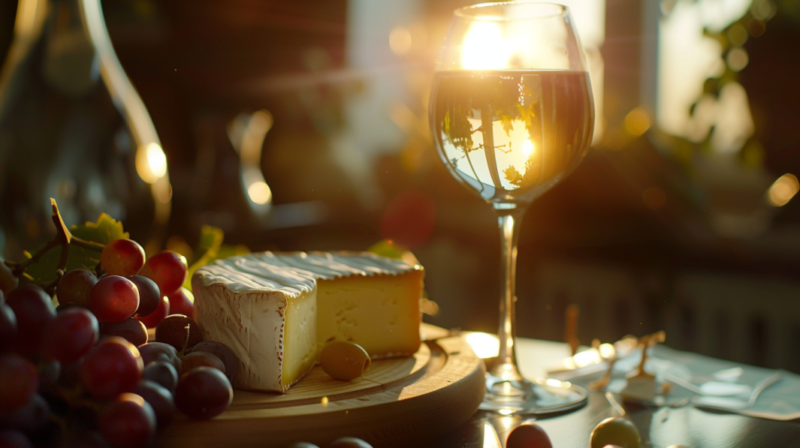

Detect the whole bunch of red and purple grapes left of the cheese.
[{"left": 0, "top": 239, "right": 238, "bottom": 448}]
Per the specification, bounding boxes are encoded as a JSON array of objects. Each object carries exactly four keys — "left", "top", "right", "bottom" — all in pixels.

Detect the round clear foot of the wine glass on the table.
[{"left": 479, "top": 374, "right": 589, "bottom": 417}]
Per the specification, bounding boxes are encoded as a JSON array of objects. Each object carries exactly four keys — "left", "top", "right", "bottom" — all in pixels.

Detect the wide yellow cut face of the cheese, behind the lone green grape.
[{"left": 316, "top": 270, "right": 424, "bottom": 358}]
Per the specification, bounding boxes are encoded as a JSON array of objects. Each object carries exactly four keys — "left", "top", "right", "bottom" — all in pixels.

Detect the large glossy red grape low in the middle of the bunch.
[{"left": 80, "top": 336, "right": 144, "bottom": 400}]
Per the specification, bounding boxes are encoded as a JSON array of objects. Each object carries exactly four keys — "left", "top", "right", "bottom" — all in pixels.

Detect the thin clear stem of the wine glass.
[{"left": 490, "top": 209, "right": 524, "bottom": 381}]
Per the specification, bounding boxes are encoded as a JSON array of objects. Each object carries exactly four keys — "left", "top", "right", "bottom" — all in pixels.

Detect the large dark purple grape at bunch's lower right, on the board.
[{"left": 175, "top": 367, "right": 233, "bottom": 420}]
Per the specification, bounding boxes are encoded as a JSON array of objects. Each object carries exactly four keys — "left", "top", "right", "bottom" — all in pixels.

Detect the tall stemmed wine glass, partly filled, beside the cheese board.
[{"left": 430, "top": 2, "right": 594, "bottom": 415}]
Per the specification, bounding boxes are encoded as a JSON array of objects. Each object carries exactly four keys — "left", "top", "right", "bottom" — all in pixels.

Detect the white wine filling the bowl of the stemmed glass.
[{"left": 430, "top": 70, "right": 594, "bottom": 208}]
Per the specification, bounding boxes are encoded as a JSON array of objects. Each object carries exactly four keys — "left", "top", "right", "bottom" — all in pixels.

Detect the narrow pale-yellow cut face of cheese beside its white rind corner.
[{"left": 281, "top": 290, "right": 317, "bottom": 390}]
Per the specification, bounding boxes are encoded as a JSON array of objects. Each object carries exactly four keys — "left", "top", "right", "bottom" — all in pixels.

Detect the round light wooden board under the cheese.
[{"left": 156, "top": 324, "right": 484, "bottom": 448}]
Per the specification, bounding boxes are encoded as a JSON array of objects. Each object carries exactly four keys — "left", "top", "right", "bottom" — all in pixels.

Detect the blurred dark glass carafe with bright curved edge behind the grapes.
[{"left": 0, "top": 0, "right": 172, "bottom": 258}]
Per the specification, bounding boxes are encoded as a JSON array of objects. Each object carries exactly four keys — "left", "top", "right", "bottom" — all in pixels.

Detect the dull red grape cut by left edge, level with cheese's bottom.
[{"left": 0, "top": 353, "right": 39, "bottom": 415}]
